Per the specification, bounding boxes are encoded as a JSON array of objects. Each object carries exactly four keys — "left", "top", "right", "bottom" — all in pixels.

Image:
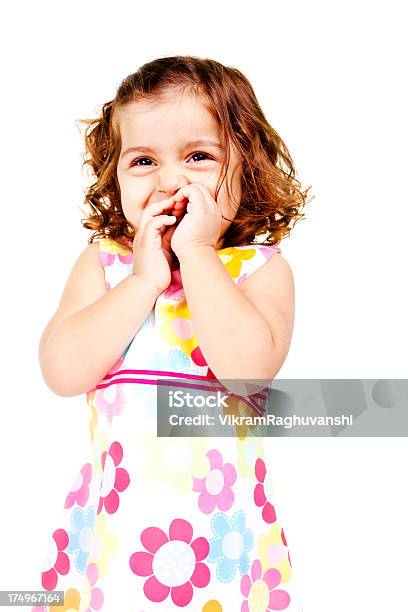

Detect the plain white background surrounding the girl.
[{"left": 0, "top": 0, "right": 408, "bottom": 612}]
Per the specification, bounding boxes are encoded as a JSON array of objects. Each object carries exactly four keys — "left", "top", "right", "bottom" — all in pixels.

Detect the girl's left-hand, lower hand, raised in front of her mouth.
[{"left": 133, "top": 200, "right": 176, "bottom": 295}]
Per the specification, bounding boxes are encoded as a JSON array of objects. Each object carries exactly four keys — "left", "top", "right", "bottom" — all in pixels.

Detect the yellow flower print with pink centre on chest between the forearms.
[{"left": 156, "top": 300, "right": 198, "bottom": 357}]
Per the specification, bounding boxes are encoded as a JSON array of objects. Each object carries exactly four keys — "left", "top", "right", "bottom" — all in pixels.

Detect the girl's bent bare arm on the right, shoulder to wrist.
[{"left": 179, "top": 246, "right": 294, "bottom": 381}]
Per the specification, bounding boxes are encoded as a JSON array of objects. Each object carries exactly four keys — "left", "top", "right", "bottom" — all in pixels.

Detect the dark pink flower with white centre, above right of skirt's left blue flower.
[{"left": 97, "top": 442, "right": 130, "bottom": 514}]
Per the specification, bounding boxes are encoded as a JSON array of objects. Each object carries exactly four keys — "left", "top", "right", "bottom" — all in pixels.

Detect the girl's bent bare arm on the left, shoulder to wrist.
[{"left": 39, "top": 243, "right": 158, "bottom": 396}]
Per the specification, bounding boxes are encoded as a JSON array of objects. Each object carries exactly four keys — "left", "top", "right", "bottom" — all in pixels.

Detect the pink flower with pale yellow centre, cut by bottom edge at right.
[{"left": 241, "top": 559, "right": 290, "bottom": 612}]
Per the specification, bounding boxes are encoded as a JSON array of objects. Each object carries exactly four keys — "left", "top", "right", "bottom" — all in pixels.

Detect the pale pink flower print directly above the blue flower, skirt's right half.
[{"left": 193, "top": 448, "right": 237, "bottom": 514}]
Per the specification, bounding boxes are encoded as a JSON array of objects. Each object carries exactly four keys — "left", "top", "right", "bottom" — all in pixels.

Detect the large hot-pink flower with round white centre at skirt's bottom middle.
[{"left": 129, "top": 519, "right": 210, "bottom": 607}]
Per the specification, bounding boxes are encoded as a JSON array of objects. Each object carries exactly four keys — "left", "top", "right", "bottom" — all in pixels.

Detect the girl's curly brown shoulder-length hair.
[{"left": 79, "top": 55, "right": 310, "bottom": 248}]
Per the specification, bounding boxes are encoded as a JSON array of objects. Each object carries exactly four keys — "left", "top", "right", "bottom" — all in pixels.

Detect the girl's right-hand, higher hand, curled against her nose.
[{"left": 169, "top": 183, "right": 222, "bottom": 259}]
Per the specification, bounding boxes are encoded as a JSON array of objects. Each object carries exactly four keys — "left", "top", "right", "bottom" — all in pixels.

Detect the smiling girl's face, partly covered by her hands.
[{"left": 117, "top": 90, "right": 242, "bottom": 248}]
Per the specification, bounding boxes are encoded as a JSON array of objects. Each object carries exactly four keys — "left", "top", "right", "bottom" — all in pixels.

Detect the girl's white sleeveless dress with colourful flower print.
[{"left": 31, "top": 239, "right": 302, "bottom": 612}]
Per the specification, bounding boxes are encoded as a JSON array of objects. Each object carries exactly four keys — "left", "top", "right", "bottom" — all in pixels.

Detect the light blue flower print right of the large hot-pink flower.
[{"left": 207, "top": 510, "right": 254, "bottom": 582}]
